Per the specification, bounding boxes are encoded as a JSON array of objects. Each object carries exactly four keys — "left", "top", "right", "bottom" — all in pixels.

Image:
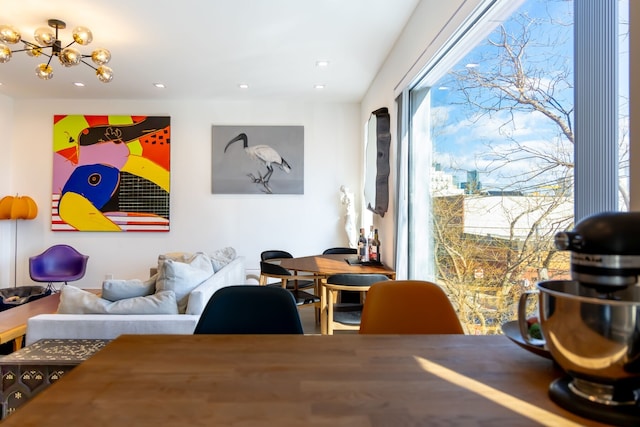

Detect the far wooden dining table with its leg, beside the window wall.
[{"left": 277, "top": 254, "right": 396, "bottom": 334}]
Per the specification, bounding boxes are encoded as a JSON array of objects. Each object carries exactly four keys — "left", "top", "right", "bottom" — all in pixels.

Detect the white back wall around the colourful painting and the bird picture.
[{"left": 6, "top": 100, "right": 361, "bottom": 288}]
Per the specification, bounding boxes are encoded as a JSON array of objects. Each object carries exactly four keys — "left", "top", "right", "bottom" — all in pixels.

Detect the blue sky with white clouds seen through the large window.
[{"left": 431, "top": 0, "right": 573, "bottom": 190}]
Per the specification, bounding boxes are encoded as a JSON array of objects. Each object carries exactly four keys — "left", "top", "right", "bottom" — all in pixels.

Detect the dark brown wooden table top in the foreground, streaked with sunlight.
[{"left": 3, "top": 334, "right": 602, "bottom": 427}]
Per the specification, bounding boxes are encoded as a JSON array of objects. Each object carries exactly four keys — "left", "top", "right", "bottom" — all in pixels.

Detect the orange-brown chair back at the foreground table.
[{"left": 360, "top": 280, "right": 464, "bottom": 334}]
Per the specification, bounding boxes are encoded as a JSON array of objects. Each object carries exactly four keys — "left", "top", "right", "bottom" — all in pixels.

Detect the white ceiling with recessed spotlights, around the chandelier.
[{"left": 0, "top": 0, "right": 419, "bottom": 102}]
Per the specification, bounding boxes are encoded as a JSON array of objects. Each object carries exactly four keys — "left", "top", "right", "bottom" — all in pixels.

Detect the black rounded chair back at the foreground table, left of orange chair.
[{"left": 193, "top": 285, "right": 304, "bottom": 334}]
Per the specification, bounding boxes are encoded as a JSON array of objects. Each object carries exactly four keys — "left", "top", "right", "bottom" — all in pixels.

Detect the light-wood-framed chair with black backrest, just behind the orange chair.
[{"left": 320, "top": 273, "right": 388, "bottom": 335}]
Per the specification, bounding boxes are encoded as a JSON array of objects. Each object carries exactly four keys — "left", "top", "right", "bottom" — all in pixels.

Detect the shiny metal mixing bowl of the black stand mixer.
[{"left": 538, "top": 280, "right": 640, "bottom": 405}]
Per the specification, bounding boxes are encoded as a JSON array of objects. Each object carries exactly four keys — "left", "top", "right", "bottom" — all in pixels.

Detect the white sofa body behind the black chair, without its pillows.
[{"left": 25, "top": 257, "right": 246, "bottom": 345}]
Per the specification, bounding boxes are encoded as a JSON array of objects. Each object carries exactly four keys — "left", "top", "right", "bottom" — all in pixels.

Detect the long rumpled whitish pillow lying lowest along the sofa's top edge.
[{"left": 58, "top": 285, "right": 178, "bottom": 314}]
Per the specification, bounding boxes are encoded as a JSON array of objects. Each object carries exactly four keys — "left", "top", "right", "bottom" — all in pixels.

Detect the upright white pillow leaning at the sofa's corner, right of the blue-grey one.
[{"left": 156, "top": 253, "right": 213, "bottom": 314}]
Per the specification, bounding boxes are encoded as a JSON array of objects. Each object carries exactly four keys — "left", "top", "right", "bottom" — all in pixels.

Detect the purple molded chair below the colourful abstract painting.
[{"left": 29, "top": 244, "right": 89, "bottom": 292}]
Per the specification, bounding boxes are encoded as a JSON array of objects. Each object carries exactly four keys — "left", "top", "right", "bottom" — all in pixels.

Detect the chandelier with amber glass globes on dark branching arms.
[{"left": 0, "top": 19, "right": 113, "bottom": 83}]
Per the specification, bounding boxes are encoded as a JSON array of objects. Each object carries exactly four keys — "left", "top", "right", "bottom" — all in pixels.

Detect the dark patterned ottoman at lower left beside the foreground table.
[{"left": 0, "top": 339, "right": 109, "bottom": 419}]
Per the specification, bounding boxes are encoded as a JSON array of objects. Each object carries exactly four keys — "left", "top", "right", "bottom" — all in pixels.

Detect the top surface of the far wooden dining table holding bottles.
[{"left": 279, "top": 254, "right": 396, "bottom": 279}]
